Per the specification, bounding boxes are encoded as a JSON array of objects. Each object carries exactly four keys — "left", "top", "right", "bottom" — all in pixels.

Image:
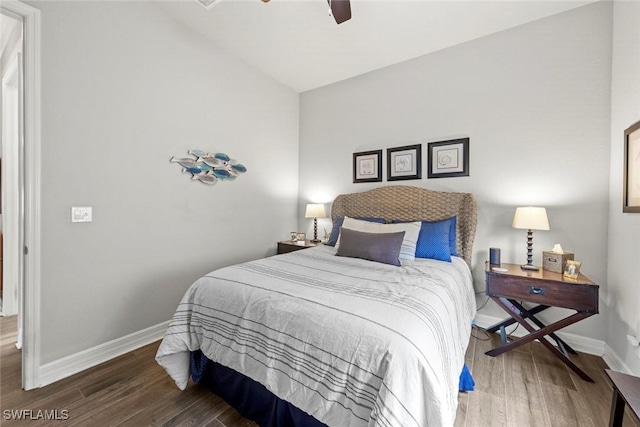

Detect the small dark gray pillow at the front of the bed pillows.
[{"left": 336, "top": 227, "right": 405, "bottom": 266}]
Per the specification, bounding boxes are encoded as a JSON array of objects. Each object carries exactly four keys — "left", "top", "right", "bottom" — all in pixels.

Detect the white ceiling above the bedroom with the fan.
[{"left": 157, "top": 0, "right": 594, "bottom": 92}]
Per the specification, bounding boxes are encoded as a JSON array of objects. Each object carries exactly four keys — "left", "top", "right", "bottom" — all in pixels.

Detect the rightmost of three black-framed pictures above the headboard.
[{"left": 427, "top": 138, "right": 469, "bottom": 178}]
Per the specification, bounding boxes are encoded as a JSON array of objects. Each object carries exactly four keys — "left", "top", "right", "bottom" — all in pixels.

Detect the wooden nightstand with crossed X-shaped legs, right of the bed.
[{"left": 485, "top": 264, "right": 599, "bottom": 382}]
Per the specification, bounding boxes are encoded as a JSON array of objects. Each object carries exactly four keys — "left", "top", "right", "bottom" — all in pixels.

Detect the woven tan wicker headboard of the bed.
[{"left": 331, "top": 185, "right": 478, "bottom": 268}]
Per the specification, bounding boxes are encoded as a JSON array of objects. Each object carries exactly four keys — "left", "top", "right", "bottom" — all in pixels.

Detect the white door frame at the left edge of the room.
[{"left": 0, "top": 0, "right": 42, "bottom": 390}]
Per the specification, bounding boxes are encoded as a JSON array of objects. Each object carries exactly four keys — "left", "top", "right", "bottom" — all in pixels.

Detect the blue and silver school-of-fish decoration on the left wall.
[{"left": 170, "top": 150, "right": 247, "bottom": 185}]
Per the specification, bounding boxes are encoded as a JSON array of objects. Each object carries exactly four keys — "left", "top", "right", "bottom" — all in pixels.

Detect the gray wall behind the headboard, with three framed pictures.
[{"left": 300, "top": 3, "right": 612, "bottom": 339}]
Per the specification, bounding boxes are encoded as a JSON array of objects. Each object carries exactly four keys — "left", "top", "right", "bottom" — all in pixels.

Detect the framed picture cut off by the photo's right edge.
[{"left": 622, "top": 122, "right": 640, "bottom": 213}]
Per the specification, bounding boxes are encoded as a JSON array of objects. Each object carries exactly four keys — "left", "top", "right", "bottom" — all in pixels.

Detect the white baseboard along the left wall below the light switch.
[{"left": 38, "top": 320, "right": 170, "bottom": 387}]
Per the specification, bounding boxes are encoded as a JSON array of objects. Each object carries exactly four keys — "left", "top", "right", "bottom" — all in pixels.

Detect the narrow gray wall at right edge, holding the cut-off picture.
[{"left": 607, "top": 1, "right": 640, "bottom": 375}]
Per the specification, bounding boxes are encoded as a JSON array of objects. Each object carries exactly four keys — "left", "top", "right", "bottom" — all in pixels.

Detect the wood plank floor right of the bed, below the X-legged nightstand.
[{"left": 455, "top": 330, "right": 640, "bottom": 427}]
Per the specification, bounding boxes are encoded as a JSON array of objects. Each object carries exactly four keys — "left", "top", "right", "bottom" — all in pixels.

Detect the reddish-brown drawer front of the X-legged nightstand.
[{"left": 487, "top": 274, "right": 598, "bottom": 313}]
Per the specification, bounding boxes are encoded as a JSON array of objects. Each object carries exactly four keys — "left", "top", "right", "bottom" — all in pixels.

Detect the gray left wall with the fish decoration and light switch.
[{"left": 30, "top": 1, "right": 298, "bottom": 363}]
